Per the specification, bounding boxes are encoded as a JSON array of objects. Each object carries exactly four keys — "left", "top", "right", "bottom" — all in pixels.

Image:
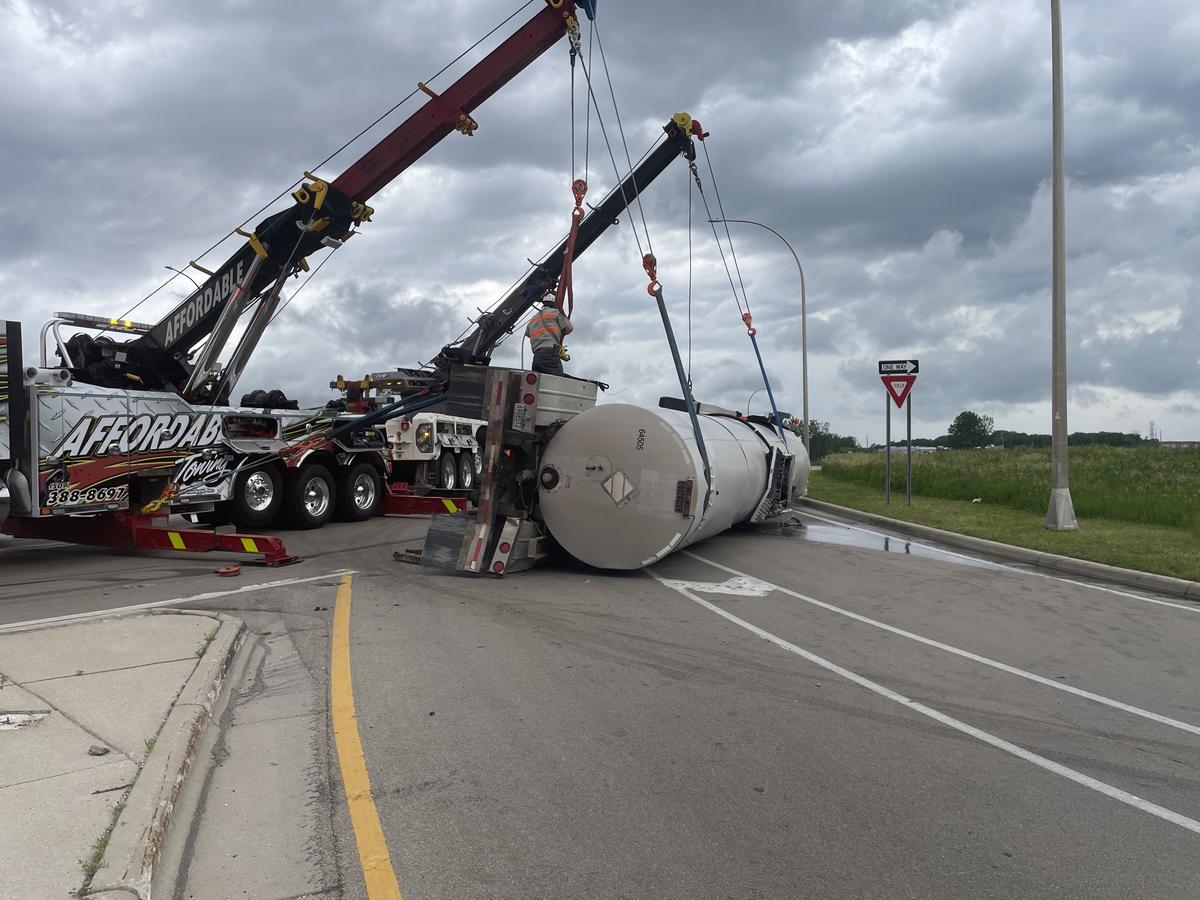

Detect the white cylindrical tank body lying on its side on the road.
[{"left": 539, "top": 403, "right": 809, "bottom": 569}]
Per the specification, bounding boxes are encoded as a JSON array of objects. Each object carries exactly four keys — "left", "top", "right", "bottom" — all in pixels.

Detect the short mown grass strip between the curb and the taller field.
[{"left": 809, "top": 467, "right": 1200, "bottom": 581}]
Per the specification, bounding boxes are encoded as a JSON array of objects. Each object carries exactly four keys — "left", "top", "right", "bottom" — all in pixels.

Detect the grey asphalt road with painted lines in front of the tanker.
[{"left": 0, "top": 511, "right": 1200, "bottom": 900}]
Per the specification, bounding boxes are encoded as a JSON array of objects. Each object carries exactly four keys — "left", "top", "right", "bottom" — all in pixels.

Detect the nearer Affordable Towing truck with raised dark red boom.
[{"left": 0, "top": 0, "right": 595, "bottom": 564}]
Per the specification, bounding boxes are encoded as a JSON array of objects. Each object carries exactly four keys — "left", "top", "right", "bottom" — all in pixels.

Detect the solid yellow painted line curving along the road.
[{"left": 330, "top": 574, "right": 403, "bottom": 900}]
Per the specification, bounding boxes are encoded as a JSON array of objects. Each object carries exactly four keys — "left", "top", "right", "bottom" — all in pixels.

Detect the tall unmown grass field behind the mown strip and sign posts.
[{"left": 822, "top": 446, "right": 1200, "bottom": 536}]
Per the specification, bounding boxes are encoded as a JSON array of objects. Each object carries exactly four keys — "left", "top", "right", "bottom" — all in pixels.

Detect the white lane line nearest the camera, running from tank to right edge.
[{"left": 647, "top": 569, "right": 1200, "bottom": 834}]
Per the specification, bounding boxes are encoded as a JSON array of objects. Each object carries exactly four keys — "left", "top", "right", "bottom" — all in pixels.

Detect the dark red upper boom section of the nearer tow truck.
[{"left": 332, "top": 0, "right": 575, "bottom": 203}]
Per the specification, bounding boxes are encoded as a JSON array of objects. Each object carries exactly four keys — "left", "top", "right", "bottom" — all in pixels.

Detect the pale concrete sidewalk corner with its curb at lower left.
[{"left": 0, "top": 611, "right": 242, "bottom": 900}]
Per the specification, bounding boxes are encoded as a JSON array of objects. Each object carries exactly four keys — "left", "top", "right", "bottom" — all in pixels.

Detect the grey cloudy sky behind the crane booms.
[{"left": 0, "top": 0, "right": 1200, "bottom": 440}]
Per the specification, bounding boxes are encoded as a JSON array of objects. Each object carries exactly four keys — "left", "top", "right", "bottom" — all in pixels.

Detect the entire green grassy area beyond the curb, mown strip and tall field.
[{"left": 809, "top": 446, "right": 1200, "bottom": 581}]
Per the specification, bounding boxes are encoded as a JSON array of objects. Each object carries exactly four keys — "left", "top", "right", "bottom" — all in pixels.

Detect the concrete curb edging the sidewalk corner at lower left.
[{"left": 86, "top": 610, "right": 245, "bottom": 900}]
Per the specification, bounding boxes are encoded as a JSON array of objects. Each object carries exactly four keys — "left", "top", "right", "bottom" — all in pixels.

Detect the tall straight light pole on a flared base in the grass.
[{"left": 1046, "top": 0, "right": 1079, "bottom": 532}]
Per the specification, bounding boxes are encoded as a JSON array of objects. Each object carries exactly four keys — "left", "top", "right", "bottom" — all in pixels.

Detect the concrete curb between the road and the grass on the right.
[{"left": 800, "top": 497, "right": 1200, "bottom": 600}]
